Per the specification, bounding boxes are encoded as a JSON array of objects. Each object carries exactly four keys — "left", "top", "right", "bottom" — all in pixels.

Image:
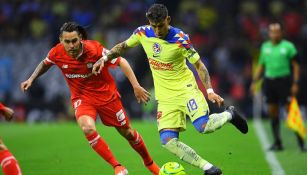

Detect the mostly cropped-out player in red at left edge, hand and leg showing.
[{"left": 0, "top": 103, "right": 21, "bottom": 175}]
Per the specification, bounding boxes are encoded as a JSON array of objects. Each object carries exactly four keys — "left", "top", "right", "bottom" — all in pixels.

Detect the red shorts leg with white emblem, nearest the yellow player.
[{"left": 97, "top": 98, "right": 130, "bottom": 128}]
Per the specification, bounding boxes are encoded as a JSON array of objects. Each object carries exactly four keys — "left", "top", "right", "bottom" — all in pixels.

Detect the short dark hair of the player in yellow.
[{"left": 146, "top": 4, "right": 168, "bottom": 22}]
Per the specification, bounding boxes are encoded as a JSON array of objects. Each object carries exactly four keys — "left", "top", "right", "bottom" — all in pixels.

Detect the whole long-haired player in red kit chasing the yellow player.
[{"left": 20, "top": 22, "right": 159, "bottom": 175}]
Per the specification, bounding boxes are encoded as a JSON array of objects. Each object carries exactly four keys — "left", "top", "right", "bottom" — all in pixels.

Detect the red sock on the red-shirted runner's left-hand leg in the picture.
[{"left": 86, "top": 132, "right": 120, "bottom": 167}]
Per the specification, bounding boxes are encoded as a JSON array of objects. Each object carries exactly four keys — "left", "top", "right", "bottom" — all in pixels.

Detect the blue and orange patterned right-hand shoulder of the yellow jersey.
[{"left": 165, "top": 26, "right": 192, "bottom": 49}]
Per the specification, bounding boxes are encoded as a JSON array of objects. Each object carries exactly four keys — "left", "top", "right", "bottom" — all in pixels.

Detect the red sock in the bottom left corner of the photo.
[{"left": 0, "top": 150, "right": 21, "bottom": 175}]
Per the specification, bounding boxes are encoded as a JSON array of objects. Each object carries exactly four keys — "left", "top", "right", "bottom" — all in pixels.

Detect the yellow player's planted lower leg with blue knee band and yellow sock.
[{"left": 160, "top": 129, "right": 222, "bottom": 175}]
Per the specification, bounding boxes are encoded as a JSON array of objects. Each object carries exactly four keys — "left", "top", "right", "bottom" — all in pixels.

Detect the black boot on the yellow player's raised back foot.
[{"left": 226, "top": 106, "right": 248, "bottom": 134}]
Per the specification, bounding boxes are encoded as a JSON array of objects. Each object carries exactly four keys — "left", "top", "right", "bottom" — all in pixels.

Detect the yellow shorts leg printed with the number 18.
[{"left": 185, "top": 90, "right": 209, "bottom": 122}]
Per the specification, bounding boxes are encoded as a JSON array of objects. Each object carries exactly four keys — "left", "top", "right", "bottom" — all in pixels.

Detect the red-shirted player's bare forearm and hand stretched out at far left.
[{"left": 20, "top": 60, "right": 52, "bottom": 92}]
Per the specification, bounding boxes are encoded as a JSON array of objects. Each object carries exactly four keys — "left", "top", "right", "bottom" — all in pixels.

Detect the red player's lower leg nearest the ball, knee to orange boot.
[{"left": 116, "top": 127, "right": 160, "bottom": 175}]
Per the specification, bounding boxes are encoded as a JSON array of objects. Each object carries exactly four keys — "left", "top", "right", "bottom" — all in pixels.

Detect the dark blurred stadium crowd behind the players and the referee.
[{"left": 0, "top": 0, "right": 307, "bottom": 122}]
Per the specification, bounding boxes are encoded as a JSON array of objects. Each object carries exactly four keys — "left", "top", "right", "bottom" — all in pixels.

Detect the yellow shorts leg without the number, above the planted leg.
[{"left": 157, "top": 103, "right": 186, "bottom": 131}]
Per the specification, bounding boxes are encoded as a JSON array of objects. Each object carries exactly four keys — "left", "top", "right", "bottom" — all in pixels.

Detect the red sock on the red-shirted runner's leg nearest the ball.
[{"left": 129, "top": 130, "right": 153, "bottom": 165}]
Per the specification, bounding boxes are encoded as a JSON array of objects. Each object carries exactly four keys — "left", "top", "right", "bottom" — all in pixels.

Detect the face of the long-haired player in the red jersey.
[{"left": 60, "top": 31, "right": 81, "bottom": 58}]
